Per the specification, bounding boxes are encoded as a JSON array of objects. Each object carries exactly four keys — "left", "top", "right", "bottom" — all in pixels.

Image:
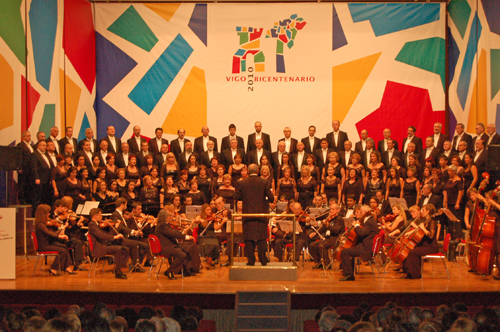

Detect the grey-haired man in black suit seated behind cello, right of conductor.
[{"left": 340, "top": 205, "right": 379, "bottom": 281}]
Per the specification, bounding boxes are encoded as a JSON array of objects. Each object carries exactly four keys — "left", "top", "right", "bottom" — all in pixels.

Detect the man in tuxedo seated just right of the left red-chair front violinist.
[{"left": 111, "top": 197, "right": 148, "bottom": 273}]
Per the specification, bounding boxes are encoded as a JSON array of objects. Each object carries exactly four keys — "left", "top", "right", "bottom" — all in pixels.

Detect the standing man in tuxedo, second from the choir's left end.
[{"left": 31, "top": 141, "right": 53, "bottom": 210}]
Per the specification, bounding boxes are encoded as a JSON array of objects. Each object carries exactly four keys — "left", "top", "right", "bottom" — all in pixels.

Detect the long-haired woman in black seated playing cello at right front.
[{"left": 403, "top": 204, "right": 438, "bottom": 279}]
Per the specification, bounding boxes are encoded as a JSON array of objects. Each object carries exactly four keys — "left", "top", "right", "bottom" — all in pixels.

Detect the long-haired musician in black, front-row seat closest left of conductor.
[{"left": 155, "top": 203, "right": 199, "bottom": 280}]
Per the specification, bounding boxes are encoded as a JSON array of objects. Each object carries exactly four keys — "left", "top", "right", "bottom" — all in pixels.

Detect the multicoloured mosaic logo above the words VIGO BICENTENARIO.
[{"left": 233, "top": 14, "right": 307, "bottom": 74}]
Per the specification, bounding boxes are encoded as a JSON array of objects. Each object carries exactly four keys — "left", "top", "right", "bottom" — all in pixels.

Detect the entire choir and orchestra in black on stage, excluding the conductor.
[{"left": 14, "top": 120, "right": 500, "bottom": 281}]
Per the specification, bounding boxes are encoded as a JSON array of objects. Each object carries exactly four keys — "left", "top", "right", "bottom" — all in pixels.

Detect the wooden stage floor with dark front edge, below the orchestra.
[{"left": 0, "top": 256, "right": 500, "bottom": 309}]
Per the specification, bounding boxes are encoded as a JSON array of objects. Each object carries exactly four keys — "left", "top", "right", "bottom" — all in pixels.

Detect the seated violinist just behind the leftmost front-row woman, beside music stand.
[{"left": 54, "top": 196, "right": 87, "bottom": 271}]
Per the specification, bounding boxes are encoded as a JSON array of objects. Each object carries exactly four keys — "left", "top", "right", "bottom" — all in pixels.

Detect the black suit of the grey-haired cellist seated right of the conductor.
[{"left": 340, "top": 216, "right": 379, "bottom": 276}]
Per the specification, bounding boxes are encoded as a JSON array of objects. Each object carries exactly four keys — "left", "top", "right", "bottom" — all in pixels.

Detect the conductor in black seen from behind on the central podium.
[{"left": 236, "top": 164, "right": 274, "bottom": 266}]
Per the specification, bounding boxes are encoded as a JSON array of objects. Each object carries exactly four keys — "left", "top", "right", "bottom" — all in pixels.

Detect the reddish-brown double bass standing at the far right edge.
[{"left": 476, "top": 187, "right": 500, "bottom": 277}]
